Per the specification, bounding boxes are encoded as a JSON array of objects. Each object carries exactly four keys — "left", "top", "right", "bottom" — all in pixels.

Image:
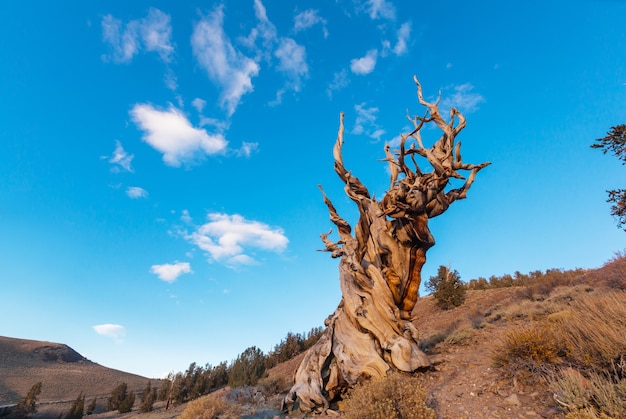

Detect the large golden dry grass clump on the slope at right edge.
[{"left": 493, "top": 294, "right": 626, "bottom": 419}]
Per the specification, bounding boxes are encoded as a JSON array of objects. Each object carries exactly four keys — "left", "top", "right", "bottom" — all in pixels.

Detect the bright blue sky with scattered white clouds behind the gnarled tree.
[{"left": 0, "top": 0, "right": 626, "bottom": 377}]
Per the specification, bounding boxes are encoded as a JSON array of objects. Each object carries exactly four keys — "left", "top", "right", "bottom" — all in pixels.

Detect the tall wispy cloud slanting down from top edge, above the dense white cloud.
[{"left": 191, "top": 7, "right": 259, "bottom": 116}]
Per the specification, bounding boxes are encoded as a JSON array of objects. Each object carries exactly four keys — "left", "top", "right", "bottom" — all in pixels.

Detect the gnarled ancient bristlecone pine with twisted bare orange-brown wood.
[{"left": 283, "top": 77, "right": 489, "bottom": 412}]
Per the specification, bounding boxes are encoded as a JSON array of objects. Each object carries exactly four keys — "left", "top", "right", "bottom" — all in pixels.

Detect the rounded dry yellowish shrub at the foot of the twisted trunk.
[{"left": 341, "top": 373, "right": 436, "bottom": 419}]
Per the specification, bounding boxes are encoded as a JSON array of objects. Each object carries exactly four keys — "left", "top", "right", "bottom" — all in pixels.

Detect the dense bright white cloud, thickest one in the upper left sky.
[{"left": 130, "top": 104, "right": 228, "bottom": 167}]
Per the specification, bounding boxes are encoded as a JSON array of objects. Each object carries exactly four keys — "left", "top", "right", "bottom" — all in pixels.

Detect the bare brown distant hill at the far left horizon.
[{"left": 0, "top": 336, "right": 151, "bottom": 405}]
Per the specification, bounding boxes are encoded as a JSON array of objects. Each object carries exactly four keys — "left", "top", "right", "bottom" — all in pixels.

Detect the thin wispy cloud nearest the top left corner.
[{"left": 102, "top": 8, "right": 174, "bottom": 63}]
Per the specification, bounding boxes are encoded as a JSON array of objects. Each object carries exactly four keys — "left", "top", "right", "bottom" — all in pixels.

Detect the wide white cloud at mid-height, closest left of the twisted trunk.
[{"left": 187, "top": 213, "right": 289, "bottom": 266}]
